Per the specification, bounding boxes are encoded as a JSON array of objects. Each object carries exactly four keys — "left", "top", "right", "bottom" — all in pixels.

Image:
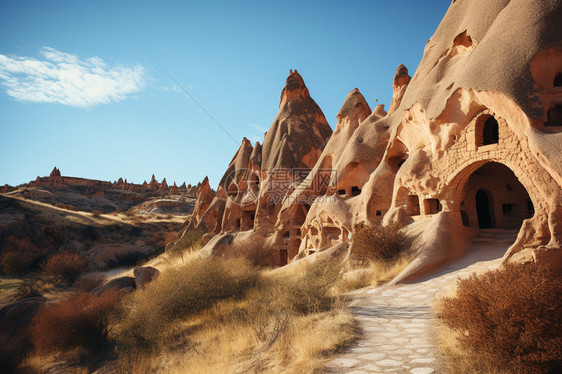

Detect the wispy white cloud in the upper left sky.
[{"left": 0, "top": 47, "right": 146, "bottom": 108}]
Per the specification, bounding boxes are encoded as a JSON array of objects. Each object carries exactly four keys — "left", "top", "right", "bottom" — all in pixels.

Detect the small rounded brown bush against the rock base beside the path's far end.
[{"left": 351, "top": 225, "right": 405, "bottom": 262}]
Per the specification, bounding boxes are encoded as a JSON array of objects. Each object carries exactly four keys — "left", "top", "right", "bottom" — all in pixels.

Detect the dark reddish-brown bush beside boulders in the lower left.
[{"left": 31, "top": 291, "right": 119, "bottom": 355}]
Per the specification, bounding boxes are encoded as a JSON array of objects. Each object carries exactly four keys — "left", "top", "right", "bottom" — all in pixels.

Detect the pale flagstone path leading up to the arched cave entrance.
[{"left": 323, "top": 244, "right": 507, "bottom": 374}]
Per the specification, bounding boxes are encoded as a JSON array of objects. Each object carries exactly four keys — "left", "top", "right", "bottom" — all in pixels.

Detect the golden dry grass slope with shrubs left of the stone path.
[{"left": 109, "top": 260, "right": 354, "bottom": 373}]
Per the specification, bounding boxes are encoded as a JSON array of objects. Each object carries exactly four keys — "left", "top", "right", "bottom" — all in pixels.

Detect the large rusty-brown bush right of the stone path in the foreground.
[{"left": 440, "top": 264, "right": 562, "bottom": 373}]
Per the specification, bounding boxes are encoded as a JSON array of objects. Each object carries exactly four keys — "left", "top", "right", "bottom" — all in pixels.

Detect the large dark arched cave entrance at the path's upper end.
[{"left": 460, "top": 162, "right": 534, "bottom": 230}]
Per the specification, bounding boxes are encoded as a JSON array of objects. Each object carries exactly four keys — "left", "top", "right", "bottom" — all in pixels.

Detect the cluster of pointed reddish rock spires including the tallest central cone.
[{"left": 183, "top": 70, "right": 332, "bottom": 258}]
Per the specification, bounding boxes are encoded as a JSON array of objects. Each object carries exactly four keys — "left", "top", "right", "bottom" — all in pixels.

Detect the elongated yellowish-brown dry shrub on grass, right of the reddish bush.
[{"left": 120, "top": 258, "right": 258, "bottom": 348}]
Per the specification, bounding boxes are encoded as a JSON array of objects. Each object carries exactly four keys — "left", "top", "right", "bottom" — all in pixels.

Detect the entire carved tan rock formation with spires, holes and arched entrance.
[{"left": 185, "top": 0, "right": 562, "bottom": 280}]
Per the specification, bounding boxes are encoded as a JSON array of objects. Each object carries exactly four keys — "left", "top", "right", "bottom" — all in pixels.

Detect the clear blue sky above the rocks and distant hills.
[{"left": 0, "top": 0, "right": 450, "bottom": 187}]
